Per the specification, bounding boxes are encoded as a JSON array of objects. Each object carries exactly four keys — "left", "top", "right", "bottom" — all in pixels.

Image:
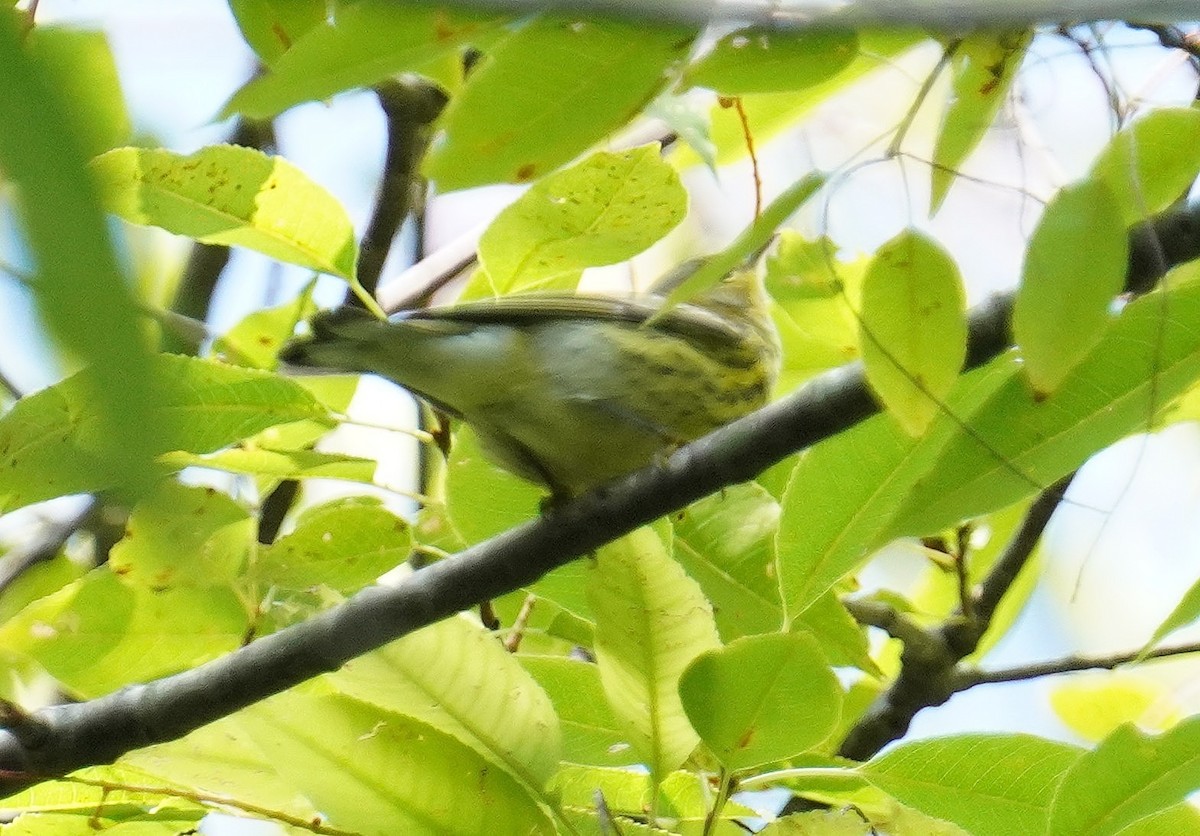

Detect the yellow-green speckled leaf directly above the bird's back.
[{"left": 479, "top": 143, "right": 688, "bottom": 295}]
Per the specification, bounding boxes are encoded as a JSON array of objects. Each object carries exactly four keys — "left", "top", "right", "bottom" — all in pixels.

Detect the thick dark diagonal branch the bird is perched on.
[{"left": 0, "top": 202, "right": 1200, "bottom": 792}]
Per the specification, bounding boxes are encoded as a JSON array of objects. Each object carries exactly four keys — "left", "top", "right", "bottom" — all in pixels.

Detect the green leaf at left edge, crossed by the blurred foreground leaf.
[{"left": 0, "top": 355, "right": 328, "bottom": 511}]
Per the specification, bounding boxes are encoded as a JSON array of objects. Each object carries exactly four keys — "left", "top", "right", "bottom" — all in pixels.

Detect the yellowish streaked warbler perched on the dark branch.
[{"left": 281, "top": 265, "right": 779, "bottom": 498}]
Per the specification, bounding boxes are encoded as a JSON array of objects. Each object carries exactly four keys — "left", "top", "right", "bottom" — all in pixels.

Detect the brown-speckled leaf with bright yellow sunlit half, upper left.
[{"left": 91, "top": 145, "right": 358, "bottom": 282}]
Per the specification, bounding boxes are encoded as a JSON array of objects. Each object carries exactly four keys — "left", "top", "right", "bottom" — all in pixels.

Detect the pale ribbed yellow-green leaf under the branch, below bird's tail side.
[{"left": 326, "top": 618, "right": 562, "bottom": 790}]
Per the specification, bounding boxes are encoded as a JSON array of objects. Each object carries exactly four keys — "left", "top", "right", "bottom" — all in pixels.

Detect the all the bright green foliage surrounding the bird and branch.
[{"left": 0, "top": 0, "right": 1200, "bottom": 835}]
